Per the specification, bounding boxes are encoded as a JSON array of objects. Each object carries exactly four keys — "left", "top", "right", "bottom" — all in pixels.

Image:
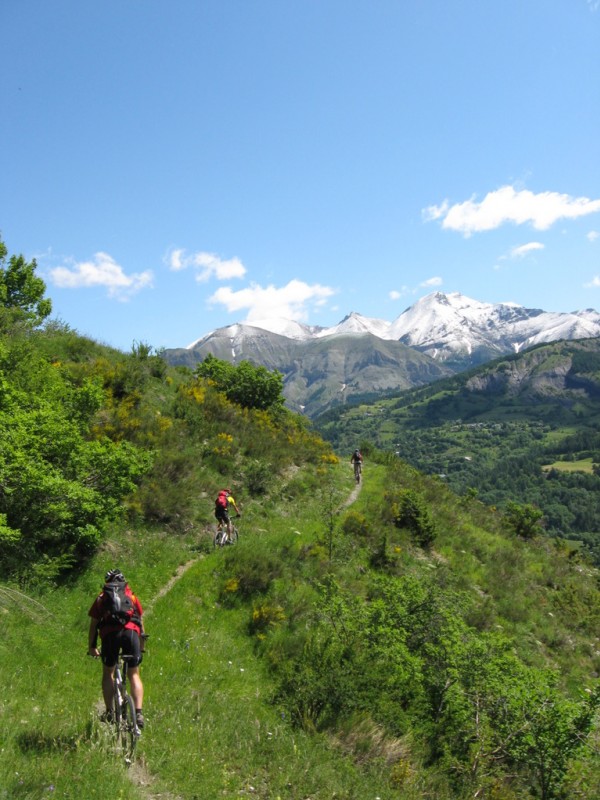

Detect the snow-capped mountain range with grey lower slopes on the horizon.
[{"left": 165, "top": 292, "right": 600, "bottom": 416}]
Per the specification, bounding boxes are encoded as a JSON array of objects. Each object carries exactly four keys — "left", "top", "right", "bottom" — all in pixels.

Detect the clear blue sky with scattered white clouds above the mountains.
[{"left": 0, "top": 0, "right": 600, "bottom": 350}]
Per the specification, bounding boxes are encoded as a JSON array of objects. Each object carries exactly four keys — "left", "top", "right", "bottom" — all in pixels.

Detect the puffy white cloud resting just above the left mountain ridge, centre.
[{"left": 209, "top": 280, "right": 335, "bottom": 322}]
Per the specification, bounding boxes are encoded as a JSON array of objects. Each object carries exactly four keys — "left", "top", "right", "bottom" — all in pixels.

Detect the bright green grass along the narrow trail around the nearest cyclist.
[{"left": 0, "top": 462, "right": 398, "bottom": 800}]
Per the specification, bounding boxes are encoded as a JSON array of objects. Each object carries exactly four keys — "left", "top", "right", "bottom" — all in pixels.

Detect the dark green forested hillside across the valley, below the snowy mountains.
[{"left": 316, "top": 339, "right": 600, "bottom": 563}]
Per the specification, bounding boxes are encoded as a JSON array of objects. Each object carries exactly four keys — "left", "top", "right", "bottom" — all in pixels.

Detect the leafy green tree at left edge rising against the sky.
[{"left": 0, "top": 240, "right": 52, "bottom": 325}]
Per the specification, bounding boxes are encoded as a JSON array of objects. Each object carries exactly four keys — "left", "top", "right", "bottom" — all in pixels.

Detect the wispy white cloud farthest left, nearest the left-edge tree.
[{"left": 50, "top": 253, "right": 153, "bottom": 300}]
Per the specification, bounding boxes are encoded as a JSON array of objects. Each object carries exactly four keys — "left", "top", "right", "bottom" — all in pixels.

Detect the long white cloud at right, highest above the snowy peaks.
[{"left": 422, "top": 186, "right": 600, "bottom": 236}]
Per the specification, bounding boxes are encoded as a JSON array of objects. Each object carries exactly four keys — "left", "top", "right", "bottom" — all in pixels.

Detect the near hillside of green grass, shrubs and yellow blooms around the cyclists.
[{"left": 0, "top": 244, "right": 600, "bottom": 800}]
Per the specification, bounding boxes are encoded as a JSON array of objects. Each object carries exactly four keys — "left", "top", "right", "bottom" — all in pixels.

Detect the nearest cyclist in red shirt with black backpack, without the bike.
[{"left": 88, "top": 569, "right": 144, "bottom": 728}]
